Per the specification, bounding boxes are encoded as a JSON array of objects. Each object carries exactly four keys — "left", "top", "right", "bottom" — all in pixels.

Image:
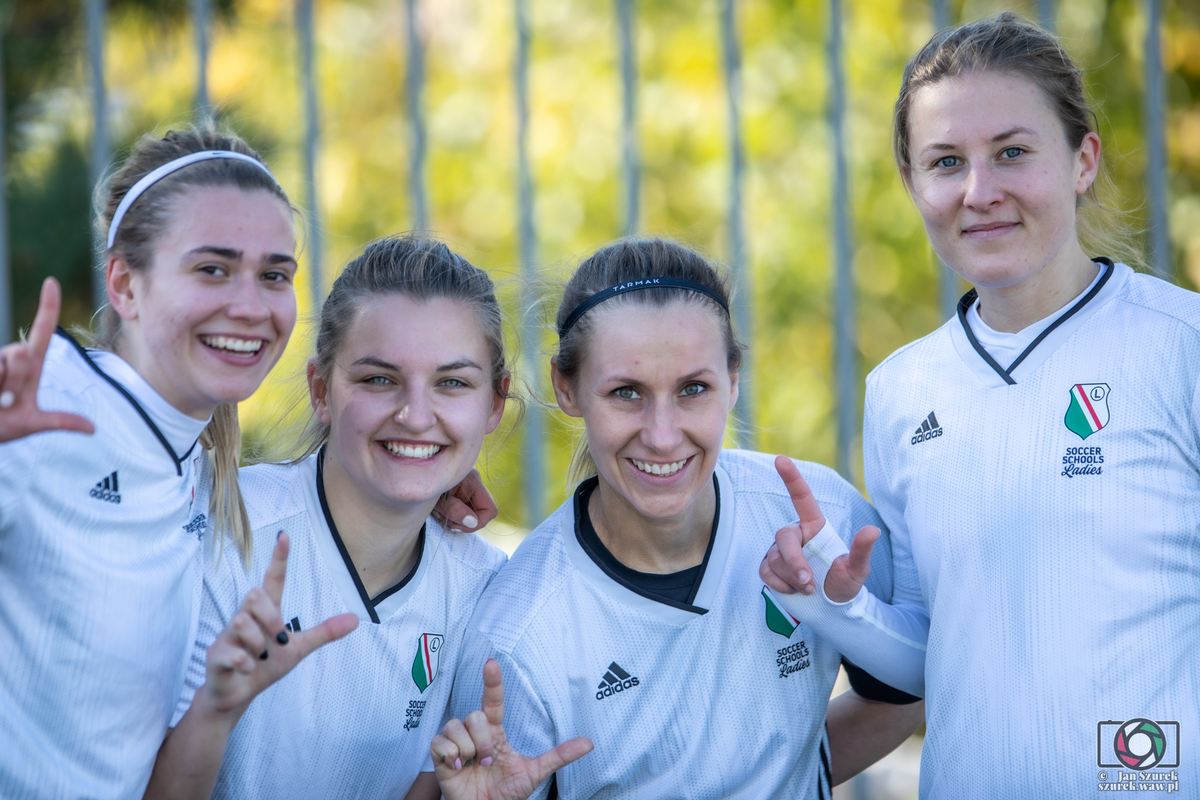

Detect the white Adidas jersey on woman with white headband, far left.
[{"left": 0, "top": 336, "right": 208, "bottom": 799}]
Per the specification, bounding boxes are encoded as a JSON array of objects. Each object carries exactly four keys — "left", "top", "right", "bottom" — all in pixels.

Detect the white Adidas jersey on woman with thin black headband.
[{"left": 454, "top": 451, "right": 892, "bottom": 800}]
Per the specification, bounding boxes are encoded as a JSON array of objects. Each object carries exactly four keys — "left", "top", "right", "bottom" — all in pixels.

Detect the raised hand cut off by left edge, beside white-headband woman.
[{"left": 0, "top": 278, "right": 96, "bottom": 441}]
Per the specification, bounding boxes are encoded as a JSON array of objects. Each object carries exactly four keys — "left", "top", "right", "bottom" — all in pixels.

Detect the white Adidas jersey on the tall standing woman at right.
[{"left": 864, "top": 264, "right": 1200, "bottom": 800}]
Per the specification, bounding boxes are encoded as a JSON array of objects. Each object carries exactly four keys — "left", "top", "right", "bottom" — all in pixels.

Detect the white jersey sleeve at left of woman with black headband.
[{"left": 450, "top": 631, "right": 558, "bottom": 800}]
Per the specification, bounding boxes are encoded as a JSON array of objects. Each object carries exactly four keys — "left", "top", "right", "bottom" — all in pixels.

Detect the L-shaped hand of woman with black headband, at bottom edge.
[{"left": 430, "top": 658, "right": 592, "bottom": 800}]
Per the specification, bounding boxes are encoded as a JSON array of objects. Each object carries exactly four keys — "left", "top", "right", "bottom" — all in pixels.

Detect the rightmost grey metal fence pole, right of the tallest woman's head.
[{"left": 1142, "top": 0, "right": 1171, "bottom": 279}]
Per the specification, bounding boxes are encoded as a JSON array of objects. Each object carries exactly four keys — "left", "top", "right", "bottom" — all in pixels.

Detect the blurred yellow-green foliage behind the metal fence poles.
[{"left": 0, "top": 0, "right": 1200, "bottom": 525}]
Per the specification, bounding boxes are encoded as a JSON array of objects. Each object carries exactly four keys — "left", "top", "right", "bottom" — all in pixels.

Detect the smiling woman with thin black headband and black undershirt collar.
[{"left": 432, "top": 240, "right": 923, "bottom": 800}]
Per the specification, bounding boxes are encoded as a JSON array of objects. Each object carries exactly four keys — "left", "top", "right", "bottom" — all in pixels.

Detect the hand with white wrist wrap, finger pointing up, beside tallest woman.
[{"left": 758, "top": 456, "right": 880, "bottom": 603}]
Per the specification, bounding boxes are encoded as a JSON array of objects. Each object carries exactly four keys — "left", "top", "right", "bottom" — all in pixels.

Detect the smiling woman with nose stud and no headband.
[{"left": 140, "top": 231, "right": 512, "bottom": 800}]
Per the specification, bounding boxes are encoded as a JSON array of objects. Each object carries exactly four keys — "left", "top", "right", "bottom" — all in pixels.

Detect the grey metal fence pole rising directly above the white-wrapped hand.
[{"left": 826, "top": 0, "right": 860, "bottom": 480}]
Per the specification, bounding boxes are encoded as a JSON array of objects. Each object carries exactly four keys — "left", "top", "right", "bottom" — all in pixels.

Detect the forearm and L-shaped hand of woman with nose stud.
[{"left": 145, "top": 531, "right": 359, "bottom": 800}]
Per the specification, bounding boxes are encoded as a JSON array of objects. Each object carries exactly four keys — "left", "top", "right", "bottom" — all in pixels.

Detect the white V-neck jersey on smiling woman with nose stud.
[{"left": 176, "top": 456, "right": 505, "bottom": 799}]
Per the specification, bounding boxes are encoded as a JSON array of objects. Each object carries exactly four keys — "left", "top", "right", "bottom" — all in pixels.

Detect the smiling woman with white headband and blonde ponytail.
[{"left": 0, "top": 128, "right": 485, "bottom": 798}]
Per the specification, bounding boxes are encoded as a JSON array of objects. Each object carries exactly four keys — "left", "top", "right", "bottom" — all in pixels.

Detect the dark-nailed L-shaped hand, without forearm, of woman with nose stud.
[{"left": 197, "top": 531, "right": 359, "bottom": 715}]
